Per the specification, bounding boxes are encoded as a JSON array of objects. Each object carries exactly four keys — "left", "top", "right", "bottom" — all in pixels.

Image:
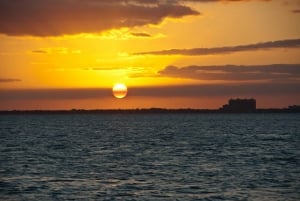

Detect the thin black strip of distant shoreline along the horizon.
[{"left": 0, "top": 108, "right": 300, "bottom": 115}]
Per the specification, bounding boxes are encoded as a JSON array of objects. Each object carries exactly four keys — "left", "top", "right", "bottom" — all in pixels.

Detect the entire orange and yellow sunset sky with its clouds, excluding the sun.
[{"left": 0, "top": 0, "right": 300, "bottom": 110}]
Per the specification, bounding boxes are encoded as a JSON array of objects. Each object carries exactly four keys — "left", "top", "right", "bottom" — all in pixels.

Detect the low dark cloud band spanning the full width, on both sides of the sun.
[{"left": 0, "top": 83, "right": 300, "bottom": 101}]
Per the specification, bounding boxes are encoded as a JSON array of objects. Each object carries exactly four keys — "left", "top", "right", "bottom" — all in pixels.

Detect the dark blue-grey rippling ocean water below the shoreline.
[{"left": 0, "top": 114, "right": 300, "bottom": 201}]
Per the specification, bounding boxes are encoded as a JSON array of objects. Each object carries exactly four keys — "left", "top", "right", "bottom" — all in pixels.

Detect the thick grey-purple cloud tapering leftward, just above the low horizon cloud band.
[{"left": 159, "top": 64, "right": 300, "bottom": 81}]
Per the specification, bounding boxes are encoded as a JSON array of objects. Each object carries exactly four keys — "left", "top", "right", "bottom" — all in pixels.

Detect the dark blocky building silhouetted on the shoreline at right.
[{"left": 220, "top": 98, "right": 256, "bottom": 112}]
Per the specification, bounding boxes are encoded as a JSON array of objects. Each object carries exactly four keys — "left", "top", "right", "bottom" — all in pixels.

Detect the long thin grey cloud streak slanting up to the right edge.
[{"left": 134, "top": 39, "right": 300, "bottom": 56}]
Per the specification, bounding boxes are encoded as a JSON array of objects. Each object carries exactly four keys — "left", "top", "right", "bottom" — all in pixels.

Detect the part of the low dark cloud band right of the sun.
[{"left": 129, "top": 83, "right": 300, "bottom": 97}]
